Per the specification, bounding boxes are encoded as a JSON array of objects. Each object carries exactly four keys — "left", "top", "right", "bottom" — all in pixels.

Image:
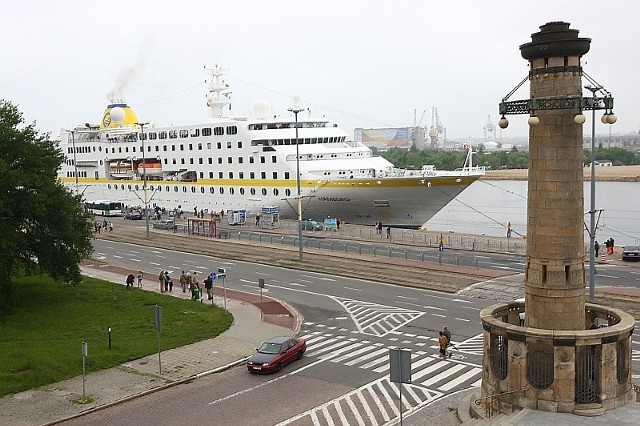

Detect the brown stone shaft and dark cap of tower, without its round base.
[{"left": 520, "top": 22, "right": 591, "bottom": 330}]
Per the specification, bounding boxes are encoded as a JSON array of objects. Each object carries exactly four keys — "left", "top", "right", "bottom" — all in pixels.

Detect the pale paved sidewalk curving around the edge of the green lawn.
[{"left": 0, "top": 264, "right": 301, "bottom": 426}]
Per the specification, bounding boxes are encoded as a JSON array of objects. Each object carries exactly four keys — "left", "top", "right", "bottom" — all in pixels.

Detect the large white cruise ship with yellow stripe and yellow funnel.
[{"left": 59, "top": 66, "right": 484, "bottom": 227}]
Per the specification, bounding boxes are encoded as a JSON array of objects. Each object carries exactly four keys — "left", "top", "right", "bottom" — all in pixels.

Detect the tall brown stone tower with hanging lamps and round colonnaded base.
[{"left": 474, "top": 22, "right": 634, "bottom": 416}]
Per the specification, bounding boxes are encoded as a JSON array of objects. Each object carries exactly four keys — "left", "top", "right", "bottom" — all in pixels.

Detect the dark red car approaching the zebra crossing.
[{"left": 247, "top": 336, "right": 307, "bottom": 373}]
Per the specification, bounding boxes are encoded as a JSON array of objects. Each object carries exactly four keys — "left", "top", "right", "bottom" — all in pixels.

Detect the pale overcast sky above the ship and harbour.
[{"left": 0, "top": 0, "right": 640, "bottom": 139}]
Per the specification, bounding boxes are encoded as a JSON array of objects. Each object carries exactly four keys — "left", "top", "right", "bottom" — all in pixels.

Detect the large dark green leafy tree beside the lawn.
[{"left": 0, "top": 99, "right": 93, "bottom": 309}]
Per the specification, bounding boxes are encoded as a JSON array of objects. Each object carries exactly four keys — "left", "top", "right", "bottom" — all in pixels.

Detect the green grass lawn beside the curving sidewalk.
[{"left": 0, "top": 277, "right": 233, "bottom": 397}]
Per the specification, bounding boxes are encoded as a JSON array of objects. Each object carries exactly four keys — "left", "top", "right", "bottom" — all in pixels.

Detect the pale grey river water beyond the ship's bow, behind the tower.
[{"left": 425, "top": 180, "right": 640, "bottom": 247}]
